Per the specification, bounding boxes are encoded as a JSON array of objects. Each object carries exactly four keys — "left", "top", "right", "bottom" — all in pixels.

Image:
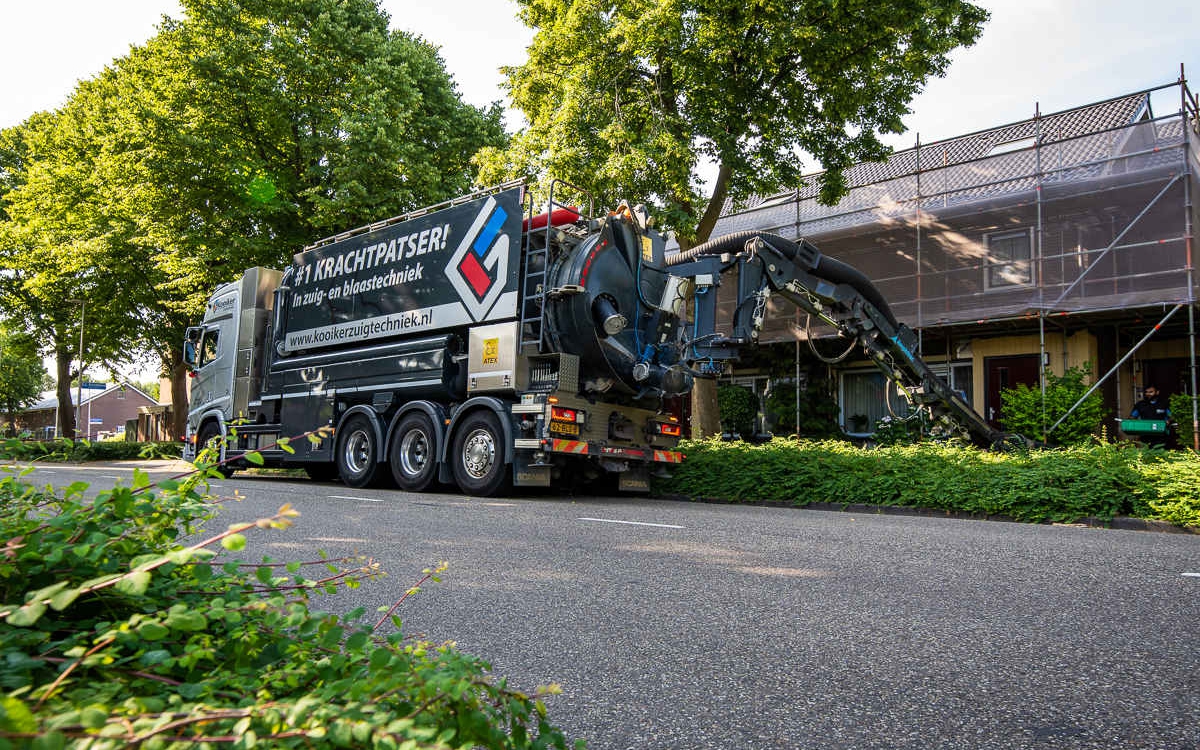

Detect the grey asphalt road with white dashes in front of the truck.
[{"left": 14, "top": 464, "right": 1200, "bottom": 750}]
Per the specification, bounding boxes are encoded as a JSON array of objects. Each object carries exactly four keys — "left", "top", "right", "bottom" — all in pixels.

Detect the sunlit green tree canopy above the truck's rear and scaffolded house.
[{"left": 480, "top": 0, "right": 988, "bottom": 246}]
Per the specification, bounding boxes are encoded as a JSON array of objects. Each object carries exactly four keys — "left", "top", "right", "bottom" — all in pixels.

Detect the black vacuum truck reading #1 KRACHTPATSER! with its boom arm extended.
[{"left": 184, "top": 184, "right": 1004, "bottom": 496}]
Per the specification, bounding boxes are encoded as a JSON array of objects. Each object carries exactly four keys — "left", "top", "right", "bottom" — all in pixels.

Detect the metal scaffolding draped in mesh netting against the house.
[{"left": 716, "top": 73, "right": 1200, "bottom": 448}]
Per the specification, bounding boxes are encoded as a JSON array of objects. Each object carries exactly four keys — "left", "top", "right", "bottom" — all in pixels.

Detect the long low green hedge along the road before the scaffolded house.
[{"left": 654, "top": 439, "right": 1200, "bottom": 528}]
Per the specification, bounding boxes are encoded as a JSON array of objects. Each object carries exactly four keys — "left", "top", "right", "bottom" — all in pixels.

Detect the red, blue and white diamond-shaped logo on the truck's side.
[{"left": 445, "top": 198, "right": 509, "bottom": 320}]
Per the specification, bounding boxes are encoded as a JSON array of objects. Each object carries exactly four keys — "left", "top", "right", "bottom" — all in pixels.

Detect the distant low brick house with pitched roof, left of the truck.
[{"left": 17, "top": 383, "right": 157, "bottom": 440}]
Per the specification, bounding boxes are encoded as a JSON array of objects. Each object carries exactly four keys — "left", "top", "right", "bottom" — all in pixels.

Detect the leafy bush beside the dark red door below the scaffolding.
[{"left": 1000, "top": 364, "right": 1109, "bottom": 445}]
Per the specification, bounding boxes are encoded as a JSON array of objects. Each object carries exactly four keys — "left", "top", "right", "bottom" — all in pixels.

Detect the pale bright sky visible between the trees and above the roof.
[{"left": 0, "top": 0, "right": 1200, "bottom": 147}]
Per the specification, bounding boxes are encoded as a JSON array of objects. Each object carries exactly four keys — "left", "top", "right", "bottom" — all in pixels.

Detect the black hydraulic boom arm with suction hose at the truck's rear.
[{"left": 666, "top": 232, "right": 1013, "bottom": 448}]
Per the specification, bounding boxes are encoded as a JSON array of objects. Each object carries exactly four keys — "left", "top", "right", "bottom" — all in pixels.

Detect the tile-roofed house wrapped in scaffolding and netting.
[{"left": 714, "top": 77, "right": 1200, "bottom": 434}]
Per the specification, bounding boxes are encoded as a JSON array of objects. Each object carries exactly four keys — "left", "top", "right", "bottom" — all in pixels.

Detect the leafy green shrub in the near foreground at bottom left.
[{"left": 0, "top": 441, "right": 580, "bottom": 749}]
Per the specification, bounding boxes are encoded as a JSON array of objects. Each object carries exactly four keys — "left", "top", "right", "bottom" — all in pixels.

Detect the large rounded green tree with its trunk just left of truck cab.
[{"left": 1, "top": 0, "right": 504, "bottom": 439}]
